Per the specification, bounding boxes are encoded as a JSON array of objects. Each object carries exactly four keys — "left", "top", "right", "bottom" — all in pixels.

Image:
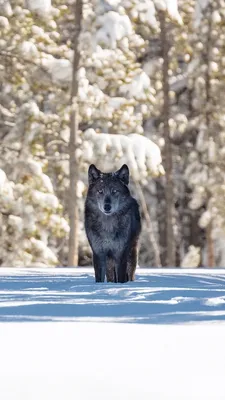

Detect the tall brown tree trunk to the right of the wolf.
[{"left": 159, "top": 11, "right": 176, "bottom": 267}]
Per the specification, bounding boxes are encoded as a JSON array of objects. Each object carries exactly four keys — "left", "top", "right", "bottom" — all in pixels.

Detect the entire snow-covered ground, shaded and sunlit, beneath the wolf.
[{"left": 0, "top": 268, "right": 225, "bottom": 400}]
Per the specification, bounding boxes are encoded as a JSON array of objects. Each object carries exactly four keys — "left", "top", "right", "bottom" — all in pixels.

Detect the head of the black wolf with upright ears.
[{"left": 88, "top": 164, "right": 130, "bottom": 215}]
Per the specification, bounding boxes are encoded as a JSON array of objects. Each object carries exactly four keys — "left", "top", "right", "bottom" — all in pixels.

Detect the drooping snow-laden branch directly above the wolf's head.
[{"left": 80, "top": 129, "right": 164, "bottom": 181}]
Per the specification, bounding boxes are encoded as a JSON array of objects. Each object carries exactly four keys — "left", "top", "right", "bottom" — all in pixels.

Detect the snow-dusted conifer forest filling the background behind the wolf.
[{"left": 0, "top": 0, "right": 225, "bottom": 267}]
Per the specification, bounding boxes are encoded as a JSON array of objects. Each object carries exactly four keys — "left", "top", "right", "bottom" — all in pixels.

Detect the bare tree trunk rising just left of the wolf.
[{"left": 68, "top": 0, "right": 83, "bottom": 266}]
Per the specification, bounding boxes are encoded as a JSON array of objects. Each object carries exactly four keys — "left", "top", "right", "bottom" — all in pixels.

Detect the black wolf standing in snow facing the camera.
[{"left": 85, "top": 164, "right": 141, "bottom": 283}]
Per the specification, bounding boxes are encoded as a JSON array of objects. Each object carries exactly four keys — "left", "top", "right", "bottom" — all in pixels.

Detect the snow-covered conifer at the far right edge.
[{"left": 186, "top": 0, "right": 225, "bottom": 267}]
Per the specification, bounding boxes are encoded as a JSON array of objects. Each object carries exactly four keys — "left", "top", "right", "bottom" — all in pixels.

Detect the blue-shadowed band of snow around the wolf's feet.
[{"left": 0, "top": 268, "right": 225, "bottom": 324}]
